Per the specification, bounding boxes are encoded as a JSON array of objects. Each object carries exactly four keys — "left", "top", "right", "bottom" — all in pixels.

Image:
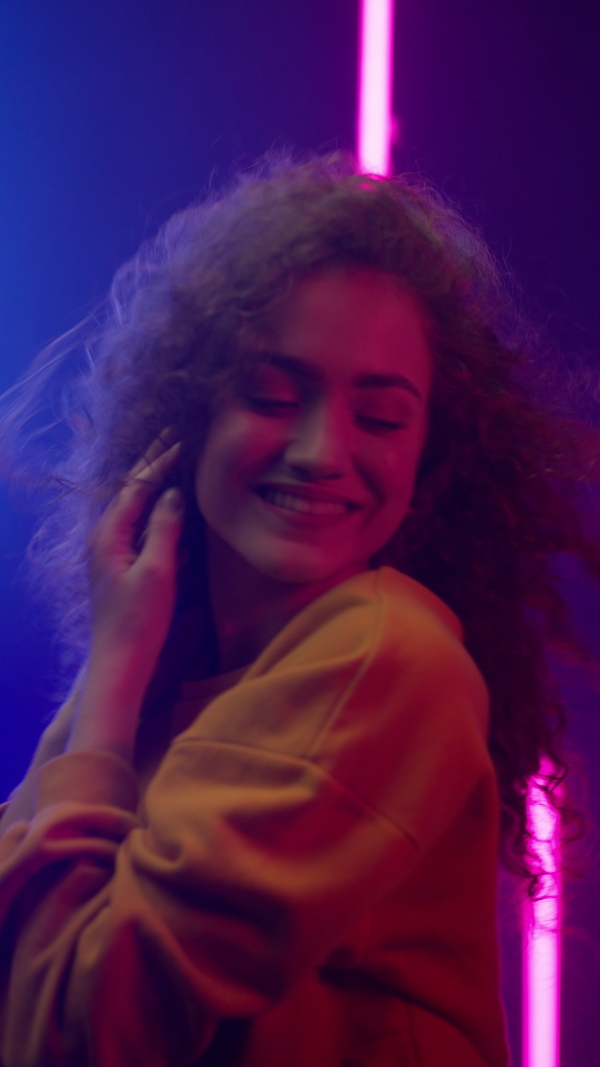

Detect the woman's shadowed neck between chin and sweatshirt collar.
[{"left": 206, "top": 530, "right": 362, "bottom": 673}]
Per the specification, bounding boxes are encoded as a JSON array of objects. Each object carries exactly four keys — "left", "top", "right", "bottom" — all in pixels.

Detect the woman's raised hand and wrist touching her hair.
[{"left": 68, "top": 440, "right": 184, "bottom": 759}]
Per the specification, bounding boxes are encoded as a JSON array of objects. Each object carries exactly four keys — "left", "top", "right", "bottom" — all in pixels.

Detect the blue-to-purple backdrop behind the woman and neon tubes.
[{"left": 0, "top": 0, "right": 600, "bottom": 1067}]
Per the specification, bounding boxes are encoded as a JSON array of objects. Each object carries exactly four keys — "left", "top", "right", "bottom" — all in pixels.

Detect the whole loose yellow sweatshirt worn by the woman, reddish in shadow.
[{"left": 0, "top": 568, "right": 507, "bottom": 1067}]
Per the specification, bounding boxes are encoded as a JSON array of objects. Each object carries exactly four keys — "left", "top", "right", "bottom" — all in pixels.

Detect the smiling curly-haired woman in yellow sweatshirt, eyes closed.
[{"left": 0, "top": 159, "right": 598, "bottom": 1067}]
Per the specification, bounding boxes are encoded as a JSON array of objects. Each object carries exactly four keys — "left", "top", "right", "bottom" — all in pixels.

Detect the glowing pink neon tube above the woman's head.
[{"left": 357, "top": 0, "right": 394, "bottom": 175}]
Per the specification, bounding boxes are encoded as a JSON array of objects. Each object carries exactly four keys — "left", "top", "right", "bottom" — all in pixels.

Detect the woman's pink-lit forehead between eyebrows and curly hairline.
[{"left": 254, "top": 270, "right": 431, "bottom": 394}]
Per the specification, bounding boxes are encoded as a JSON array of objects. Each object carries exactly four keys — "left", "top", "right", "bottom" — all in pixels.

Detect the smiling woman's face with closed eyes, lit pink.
[{"left": 195, "top": 270, "right": 431, "bottom": 583}]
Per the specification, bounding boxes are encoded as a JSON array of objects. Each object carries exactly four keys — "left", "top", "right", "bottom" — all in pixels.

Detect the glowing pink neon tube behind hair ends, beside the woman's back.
[{"left": 523, "top": 764, "right": 560, "bottom": 1067}]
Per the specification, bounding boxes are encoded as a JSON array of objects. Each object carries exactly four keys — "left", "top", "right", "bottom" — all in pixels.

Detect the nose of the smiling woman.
[{"left": 285, "top": 400, "right": 350, "bottom": 480}]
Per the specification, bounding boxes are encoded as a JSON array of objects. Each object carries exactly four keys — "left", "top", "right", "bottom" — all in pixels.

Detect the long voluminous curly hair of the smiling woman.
[{"left": 2, "top": 156, "right": 600, "bottom": 894}]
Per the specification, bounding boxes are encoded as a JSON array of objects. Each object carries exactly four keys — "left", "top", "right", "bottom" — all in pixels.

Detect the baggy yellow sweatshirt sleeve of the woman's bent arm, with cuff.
[{"left": 0, "top": 571, "right": 489, "bottom": 1067}]
